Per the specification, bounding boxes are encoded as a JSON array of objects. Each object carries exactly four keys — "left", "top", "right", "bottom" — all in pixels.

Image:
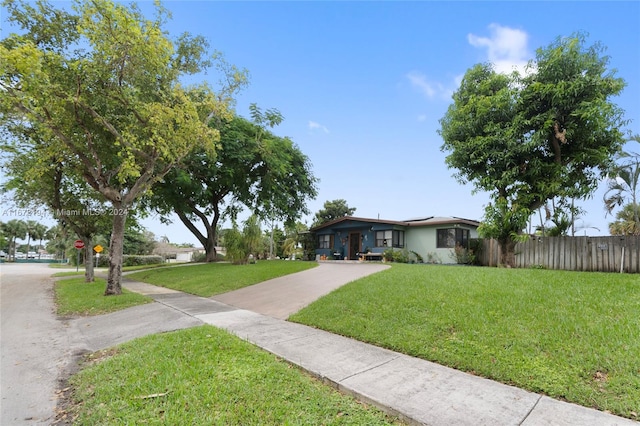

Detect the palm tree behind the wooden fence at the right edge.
[{"left": 604, "top": 135, "right": 640, "bottom": 230}]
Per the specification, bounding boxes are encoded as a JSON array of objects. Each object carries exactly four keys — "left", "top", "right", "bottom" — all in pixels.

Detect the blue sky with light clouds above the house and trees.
[{"left": 0, "top": 1, "right": 640, "bottom": 245}]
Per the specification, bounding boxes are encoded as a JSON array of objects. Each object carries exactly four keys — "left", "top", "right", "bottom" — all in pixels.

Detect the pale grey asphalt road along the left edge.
[{"left": 0, "top": 263, "right": 77, "bottom": 426}]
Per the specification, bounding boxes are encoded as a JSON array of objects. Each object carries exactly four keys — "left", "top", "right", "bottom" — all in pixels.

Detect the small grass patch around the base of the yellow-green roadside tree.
[{"left": 55, "top": 277, "right": 153, "bottom": 316}]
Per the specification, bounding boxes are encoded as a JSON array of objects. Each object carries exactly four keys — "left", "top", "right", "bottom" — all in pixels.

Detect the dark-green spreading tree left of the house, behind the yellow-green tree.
[{"left": 150, "top": 105, "right": 316, "bottom": 262}]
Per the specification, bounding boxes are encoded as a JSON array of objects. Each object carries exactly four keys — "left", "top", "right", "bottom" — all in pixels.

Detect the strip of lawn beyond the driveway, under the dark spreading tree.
[{"left": 127, "top": 260, "right": 318, "bottom": 297}]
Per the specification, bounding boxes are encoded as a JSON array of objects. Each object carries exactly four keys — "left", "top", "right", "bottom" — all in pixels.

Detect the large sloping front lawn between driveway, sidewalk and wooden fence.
[{"left": 290, "top": 264, "right": 640, "bottom": 420}]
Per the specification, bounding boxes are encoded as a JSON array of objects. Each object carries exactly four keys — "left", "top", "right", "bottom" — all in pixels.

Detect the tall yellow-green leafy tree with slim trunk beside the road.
[{"left": 0, "top": 0, "right": 244, "bottom": 295}]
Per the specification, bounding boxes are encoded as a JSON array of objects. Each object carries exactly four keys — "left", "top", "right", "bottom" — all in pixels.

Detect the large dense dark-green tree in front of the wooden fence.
[{"left": 439, "top": 34, "right": 626, "bottom": 265}]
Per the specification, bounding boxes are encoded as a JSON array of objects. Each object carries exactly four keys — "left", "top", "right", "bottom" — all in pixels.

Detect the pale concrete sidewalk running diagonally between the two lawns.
[{"left": 111, "top": 268, "right": 638, "bottom": 426}]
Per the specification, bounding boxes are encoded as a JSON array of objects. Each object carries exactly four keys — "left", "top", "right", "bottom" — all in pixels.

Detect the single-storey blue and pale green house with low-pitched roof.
[{"left": 309, "top": 216, "right": 480, "bottom": 263}]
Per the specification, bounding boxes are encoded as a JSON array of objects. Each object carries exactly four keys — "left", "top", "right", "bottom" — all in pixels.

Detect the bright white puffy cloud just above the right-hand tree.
[{"left": 467, "top": 24, "right": 530, "bottom": 73}]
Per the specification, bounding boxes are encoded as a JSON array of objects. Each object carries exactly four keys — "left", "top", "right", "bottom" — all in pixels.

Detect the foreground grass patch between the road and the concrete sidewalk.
[{"left": 67, "top": 324, "right": 400, "bottom": 425}]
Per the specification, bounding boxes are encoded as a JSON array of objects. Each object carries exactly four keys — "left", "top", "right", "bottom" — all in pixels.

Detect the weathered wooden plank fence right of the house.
[{"left": 476, "top": 236, "right": 640, "bottom": 273}]
